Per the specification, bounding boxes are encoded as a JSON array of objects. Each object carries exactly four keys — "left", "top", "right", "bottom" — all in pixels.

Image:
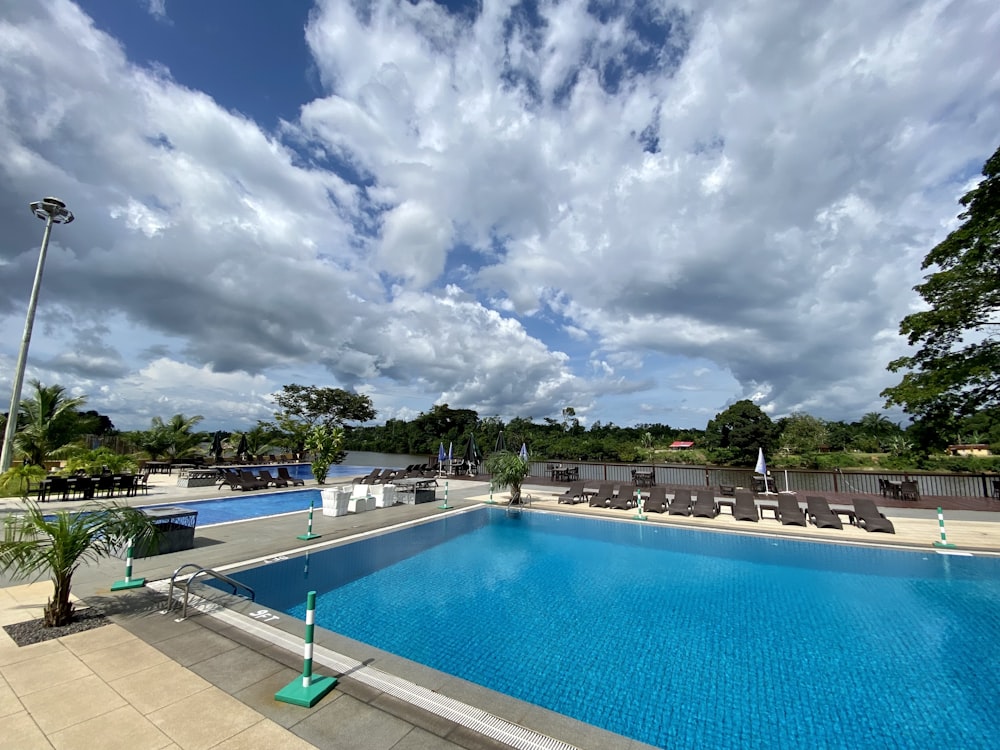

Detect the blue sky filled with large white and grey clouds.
[{"left": 0, "top": 0, "right": 1000, "bottom": 430}]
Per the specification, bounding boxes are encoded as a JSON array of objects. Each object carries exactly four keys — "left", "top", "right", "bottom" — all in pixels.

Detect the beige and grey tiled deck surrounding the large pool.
[{"left": 0, "top": 475, "right": 1000, "bottom": 750}]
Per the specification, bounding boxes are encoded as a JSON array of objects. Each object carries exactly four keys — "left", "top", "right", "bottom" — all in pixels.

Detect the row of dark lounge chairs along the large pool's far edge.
[{"left": 558, "top": 488, "right": 896, "bottom": 534}]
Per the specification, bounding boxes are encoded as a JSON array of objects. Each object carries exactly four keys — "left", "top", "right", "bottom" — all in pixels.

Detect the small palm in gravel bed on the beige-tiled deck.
[{"left": 0, "top": 500, "right": 156, "bottom": 627}]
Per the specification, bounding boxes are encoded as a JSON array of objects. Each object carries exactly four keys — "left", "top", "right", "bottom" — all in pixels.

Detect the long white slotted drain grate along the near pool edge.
[{"left": 149, "top": 580, "right": 579, "bottom": 750}]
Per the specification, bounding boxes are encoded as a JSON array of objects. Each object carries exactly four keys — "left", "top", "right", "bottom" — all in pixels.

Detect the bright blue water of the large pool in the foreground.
[{"left": 215, "top": 508, "right": 1000, "bottom": 749}]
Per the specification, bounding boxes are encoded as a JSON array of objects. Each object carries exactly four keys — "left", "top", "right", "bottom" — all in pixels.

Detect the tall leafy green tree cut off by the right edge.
[{"left": 882, "top": 148, "right": 1000, "bottom": 432}]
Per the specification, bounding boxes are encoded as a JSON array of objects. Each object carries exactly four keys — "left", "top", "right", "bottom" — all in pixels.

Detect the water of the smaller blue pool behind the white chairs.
[{"left": 143, "top": 464, "right": 371, "bottom": 526}]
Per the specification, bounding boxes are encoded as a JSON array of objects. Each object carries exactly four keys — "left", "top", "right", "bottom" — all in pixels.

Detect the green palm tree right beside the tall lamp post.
[{"left": 14, "top": 379, "right": 87, "bottom": 466}]
